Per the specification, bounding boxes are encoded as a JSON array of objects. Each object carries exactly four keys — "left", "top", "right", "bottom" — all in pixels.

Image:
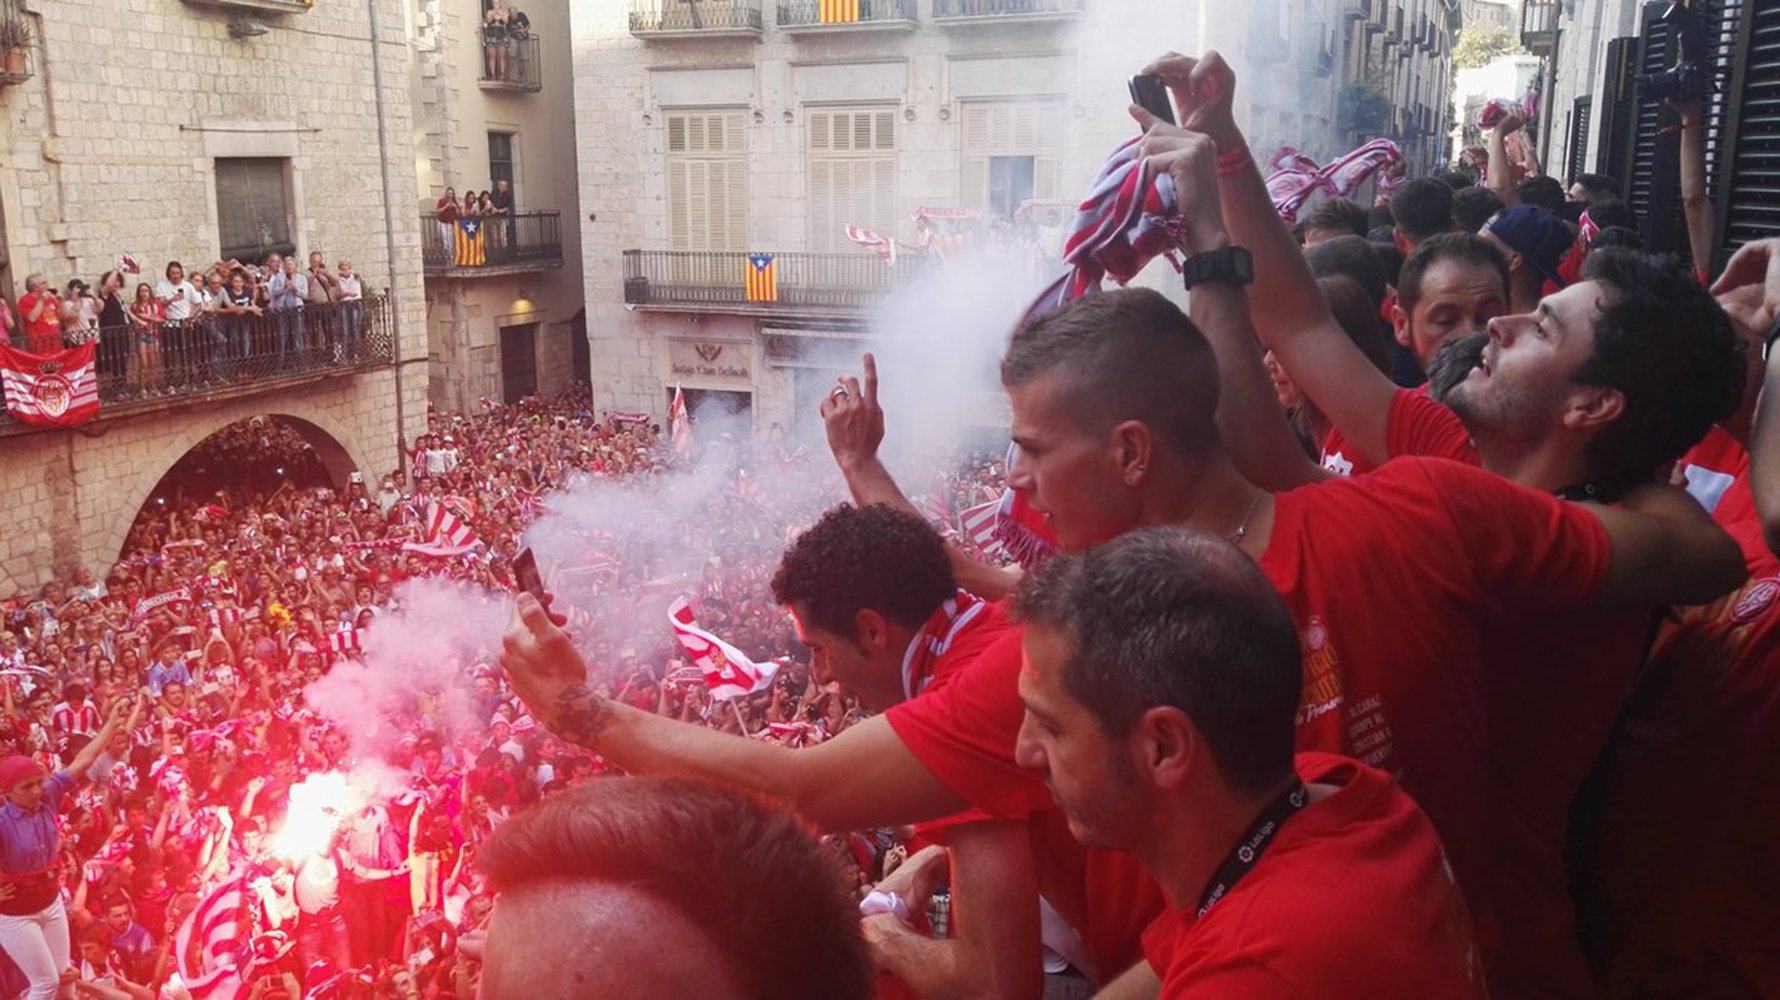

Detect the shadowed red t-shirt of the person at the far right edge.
[{"left": 1575, "top": 470, "right": 1780, "bottom": 996}]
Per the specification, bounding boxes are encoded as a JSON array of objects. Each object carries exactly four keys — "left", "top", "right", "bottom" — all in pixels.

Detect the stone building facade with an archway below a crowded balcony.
[{"left": 0, "top": 0, "right": 427, "bottom": 594}]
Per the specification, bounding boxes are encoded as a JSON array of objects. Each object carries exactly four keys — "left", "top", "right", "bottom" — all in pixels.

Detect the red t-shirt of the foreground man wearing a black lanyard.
[{"left": 1143, "top": 753, "right": 1485, "bottom": 1000}]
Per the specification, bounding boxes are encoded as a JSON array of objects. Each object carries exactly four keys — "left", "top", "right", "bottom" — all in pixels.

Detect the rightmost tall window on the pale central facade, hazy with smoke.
[{"left": 963, "top": 101, "right": 1063, "bottom": 219}]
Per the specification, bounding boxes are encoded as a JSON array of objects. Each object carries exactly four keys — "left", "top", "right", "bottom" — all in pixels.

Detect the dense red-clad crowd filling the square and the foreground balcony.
[{"left": 0, "top": 46, "right": 1780, "bottom": 1000}]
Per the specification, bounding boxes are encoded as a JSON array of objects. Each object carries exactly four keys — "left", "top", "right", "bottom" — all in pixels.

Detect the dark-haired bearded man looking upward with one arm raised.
[{"left": 1152, "top": 59, "right": 1743, "bottom": 996}]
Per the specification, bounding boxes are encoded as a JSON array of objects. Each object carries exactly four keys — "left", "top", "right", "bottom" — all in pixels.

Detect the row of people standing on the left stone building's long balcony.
[{"left": 0, "top": 251, "right": 367, "bottom": 400}]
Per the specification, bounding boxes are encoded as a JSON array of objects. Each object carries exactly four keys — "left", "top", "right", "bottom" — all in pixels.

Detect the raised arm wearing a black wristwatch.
[{"left": 1132, "top": 109, "right": 1346, "bottom": 489}]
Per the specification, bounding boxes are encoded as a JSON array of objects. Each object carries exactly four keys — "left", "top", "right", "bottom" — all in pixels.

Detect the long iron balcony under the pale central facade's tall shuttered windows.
[{"left": 625, "top": 251, "right": 924, "bottom": 317}]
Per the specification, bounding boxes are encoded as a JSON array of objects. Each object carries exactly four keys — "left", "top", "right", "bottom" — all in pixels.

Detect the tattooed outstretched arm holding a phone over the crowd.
[{"left": 500, "top": 594, "right": 967, "bottom": 831}]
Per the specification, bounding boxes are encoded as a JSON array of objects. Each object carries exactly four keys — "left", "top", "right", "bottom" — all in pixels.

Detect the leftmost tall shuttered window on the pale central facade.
[{"left": 668, "top": 110, "right": 748, "bottom": 251}]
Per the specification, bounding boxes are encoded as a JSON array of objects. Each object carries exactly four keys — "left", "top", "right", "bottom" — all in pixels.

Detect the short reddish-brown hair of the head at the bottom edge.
[{"left": 481, "top": 778, "right": 874, "bottom": 1000}]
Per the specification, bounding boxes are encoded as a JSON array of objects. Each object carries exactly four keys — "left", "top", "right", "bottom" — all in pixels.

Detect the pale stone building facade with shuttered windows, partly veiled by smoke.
[{"left": 571, "top": 0, "right": 1347, "bottom": 432}]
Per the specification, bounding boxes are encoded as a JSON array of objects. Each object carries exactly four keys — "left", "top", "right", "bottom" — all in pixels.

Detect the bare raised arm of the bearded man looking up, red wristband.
[{"left": 1146, "top": 52, "right": 1396, "bottom": 469}]
